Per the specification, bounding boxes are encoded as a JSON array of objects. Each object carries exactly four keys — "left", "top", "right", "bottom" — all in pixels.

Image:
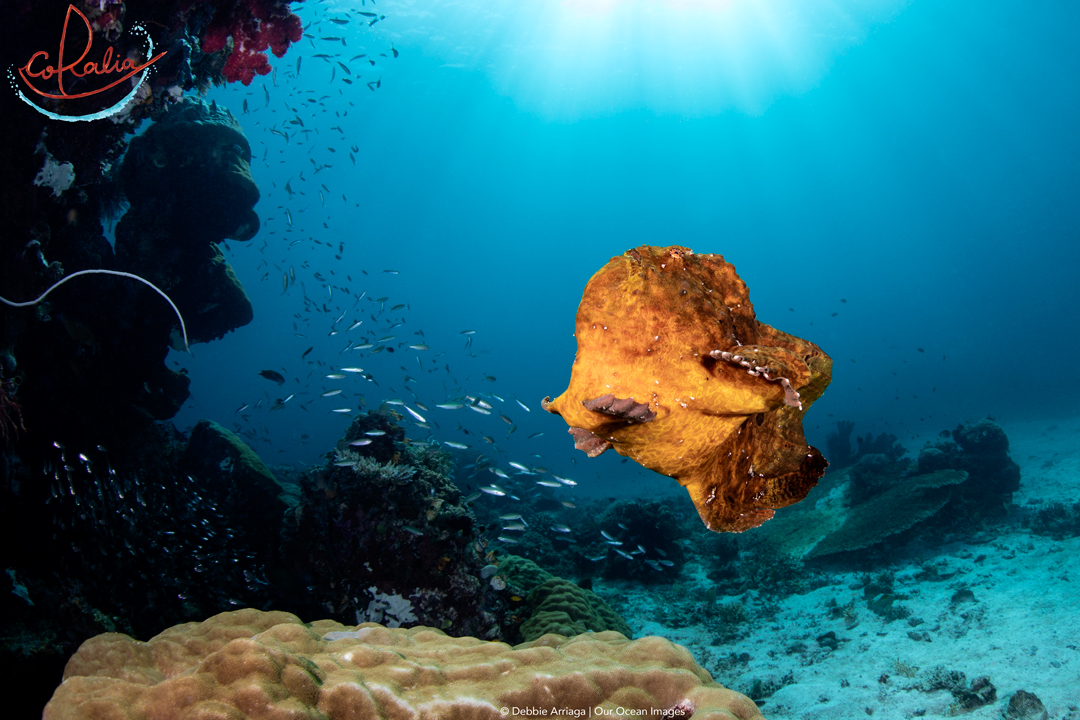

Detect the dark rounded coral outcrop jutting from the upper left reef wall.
[{"left": 116, "top": 100, "right": 259, "bottom": 343}]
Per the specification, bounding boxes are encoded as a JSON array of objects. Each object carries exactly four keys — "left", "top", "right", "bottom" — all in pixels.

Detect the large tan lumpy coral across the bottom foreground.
[{"left": 43, "top": 610, "right": 761, "bottom": 720}]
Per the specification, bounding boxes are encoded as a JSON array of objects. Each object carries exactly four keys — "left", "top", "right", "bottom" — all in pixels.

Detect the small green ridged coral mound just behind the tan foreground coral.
[{"left": 521, "top": 578, "right": 633, "bottom": 642}]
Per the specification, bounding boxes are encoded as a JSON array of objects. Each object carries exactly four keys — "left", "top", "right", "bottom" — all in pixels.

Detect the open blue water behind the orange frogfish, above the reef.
[{"left": 171, "top": 0, "right": 1080, "bottom": 494}]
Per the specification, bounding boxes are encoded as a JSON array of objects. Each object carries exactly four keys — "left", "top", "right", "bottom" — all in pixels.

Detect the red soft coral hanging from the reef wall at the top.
[{"left": 202, "top": 0, "right": 303, "bottom": 85}]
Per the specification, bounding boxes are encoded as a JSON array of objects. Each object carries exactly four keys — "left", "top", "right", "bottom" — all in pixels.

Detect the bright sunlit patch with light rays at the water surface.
[{"left": 388, "top": 0, "right": 908, "bottom": 122}]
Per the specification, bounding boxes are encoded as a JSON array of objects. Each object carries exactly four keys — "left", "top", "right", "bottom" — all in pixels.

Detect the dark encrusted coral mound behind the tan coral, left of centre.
[{"left": 282, "top": 411, "right": 499, "bottom": 637}]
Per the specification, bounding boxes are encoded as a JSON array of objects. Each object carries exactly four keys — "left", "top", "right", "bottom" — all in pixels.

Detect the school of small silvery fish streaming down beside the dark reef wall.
[{"left": 186, "top": 3, "right": 672, "bottom": 570}]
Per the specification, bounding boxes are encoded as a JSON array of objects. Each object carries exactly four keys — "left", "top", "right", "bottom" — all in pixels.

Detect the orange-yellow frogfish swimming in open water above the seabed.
[{"left": 543, "top": 245, "right": 833, "bottom": 532}]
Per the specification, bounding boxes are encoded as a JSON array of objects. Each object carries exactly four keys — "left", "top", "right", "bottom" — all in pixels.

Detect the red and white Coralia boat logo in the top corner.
[{"left": 9, "top": 5, "right": 165, "bottom": 122}]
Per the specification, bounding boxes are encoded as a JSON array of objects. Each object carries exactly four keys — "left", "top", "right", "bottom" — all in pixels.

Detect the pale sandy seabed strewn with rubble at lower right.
[{"left": 602, "top": 419, "right": 1080, "bottom": 720}]
